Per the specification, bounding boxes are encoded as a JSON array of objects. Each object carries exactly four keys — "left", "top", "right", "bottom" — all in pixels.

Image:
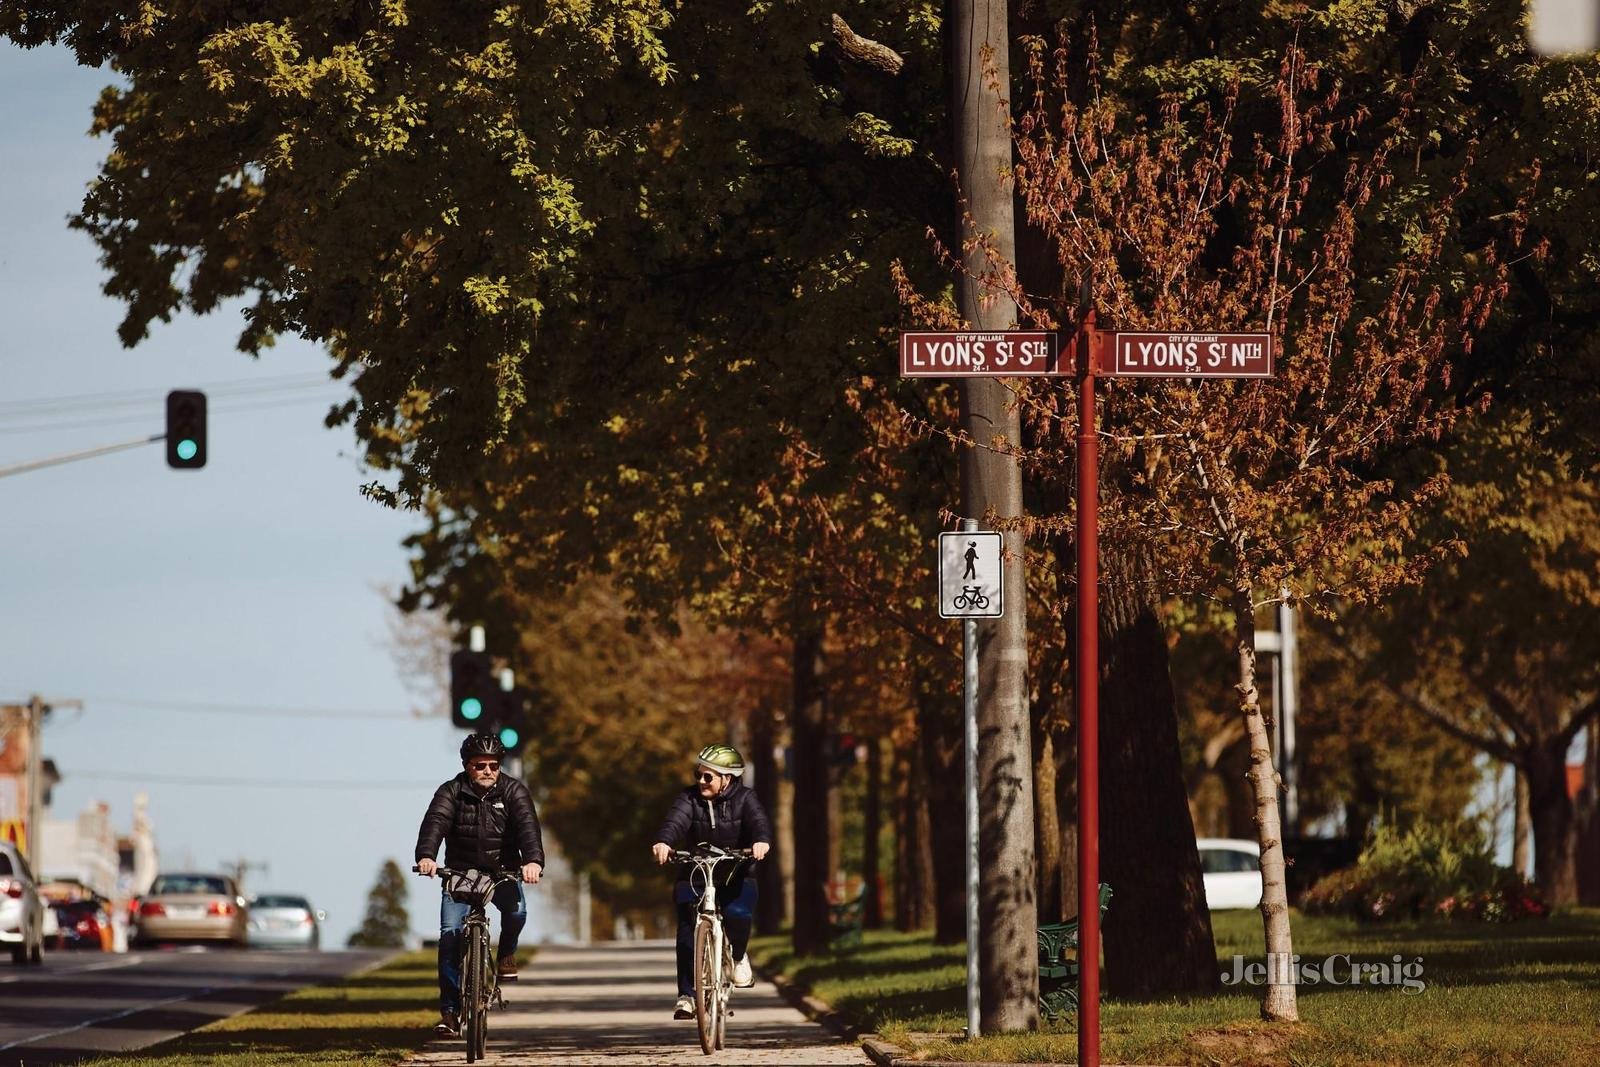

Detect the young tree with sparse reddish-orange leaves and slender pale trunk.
[{"left": 979, "top": 40, "right": 1533, "bottom": 1019}]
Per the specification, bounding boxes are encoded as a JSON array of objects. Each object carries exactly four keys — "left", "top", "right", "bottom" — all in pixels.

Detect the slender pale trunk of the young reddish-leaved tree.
[{"left": 1234, "top": 587, "right": 1299, "bottom": 1022}]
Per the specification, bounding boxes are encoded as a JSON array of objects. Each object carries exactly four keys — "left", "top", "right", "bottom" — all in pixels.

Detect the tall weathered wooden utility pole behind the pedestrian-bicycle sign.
[{"left": 946, "top": 0, "right": 1038, "bottom": 1033}]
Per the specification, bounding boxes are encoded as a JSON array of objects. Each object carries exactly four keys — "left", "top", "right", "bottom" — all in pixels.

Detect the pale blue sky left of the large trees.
[{"left": 0, "top": 43, "right": 563, "bottom": 945}]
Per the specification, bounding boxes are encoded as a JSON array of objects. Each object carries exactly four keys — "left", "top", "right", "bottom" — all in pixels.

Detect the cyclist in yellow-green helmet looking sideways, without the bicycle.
[{"left": 650, "top": 745, "right": 773, "bottom": 1019}]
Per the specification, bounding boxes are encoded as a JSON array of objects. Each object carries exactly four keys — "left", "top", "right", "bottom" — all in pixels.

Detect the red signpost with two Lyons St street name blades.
[{"left": 901, "top": 310, "right": 1275, "bottom": 1067}]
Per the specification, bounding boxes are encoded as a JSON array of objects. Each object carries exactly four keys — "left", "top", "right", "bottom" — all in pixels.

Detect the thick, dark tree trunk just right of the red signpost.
[{"left": 1099, "top": 545, "right": 1218, "bottom": 998}]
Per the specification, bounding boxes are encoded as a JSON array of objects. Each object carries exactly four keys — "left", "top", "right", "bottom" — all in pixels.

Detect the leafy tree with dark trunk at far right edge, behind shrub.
[{"left": 1338, "top": 411, "right": 1600, "bottom": 904}]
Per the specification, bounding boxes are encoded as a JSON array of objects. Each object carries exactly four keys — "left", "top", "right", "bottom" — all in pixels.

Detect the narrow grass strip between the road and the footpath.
[{"left": 75, "top": 949, "right": 438, "bottom": 1067}]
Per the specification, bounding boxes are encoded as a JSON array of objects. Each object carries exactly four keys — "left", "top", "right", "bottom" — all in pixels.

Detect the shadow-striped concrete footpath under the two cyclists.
[{"left": 406, "top": 941, "right": 869, "bottom": 1065}]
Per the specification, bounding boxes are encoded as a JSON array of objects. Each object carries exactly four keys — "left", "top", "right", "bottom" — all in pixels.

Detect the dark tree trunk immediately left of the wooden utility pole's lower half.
[{"left": 917, "top": 685, "right": 966, "bottom": 945}]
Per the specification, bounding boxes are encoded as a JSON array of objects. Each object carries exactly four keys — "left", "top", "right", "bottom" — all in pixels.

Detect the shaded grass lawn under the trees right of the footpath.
[{"left": 752, "top": 909, "right": 1600, "bottom": 1067}]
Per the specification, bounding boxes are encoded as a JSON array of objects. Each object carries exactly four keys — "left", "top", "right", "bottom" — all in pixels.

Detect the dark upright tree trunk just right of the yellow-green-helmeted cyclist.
[{"left": 790, "top": 622, "right": 829, "bottom": 955}]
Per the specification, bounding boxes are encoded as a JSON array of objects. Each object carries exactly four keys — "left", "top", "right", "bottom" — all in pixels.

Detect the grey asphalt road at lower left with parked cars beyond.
[{"left": 0, "top": 949, "right": 389, "bottom": 1067}]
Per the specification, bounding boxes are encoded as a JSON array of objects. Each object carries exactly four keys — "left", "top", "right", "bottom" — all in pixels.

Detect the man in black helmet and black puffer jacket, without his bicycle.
[{"left": 416, "top": 734, "right": 544, "bottom": 1035}]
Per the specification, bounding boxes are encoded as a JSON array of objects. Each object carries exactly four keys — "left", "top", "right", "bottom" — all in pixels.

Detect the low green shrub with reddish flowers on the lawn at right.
[{"left": 1301, "top": 822, "right": 1549, "bottom": 923}]
